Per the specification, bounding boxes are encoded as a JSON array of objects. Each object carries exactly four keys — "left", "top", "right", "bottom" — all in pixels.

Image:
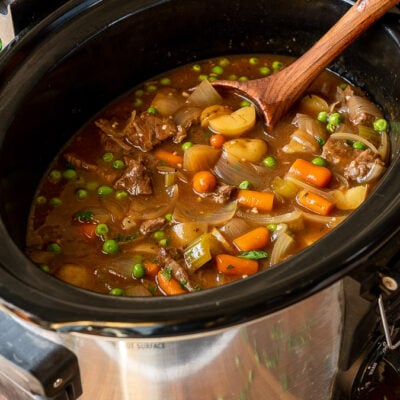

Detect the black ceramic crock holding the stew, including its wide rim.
[{"left": 0, "top": 0, "right": 400, "bottom": 335}]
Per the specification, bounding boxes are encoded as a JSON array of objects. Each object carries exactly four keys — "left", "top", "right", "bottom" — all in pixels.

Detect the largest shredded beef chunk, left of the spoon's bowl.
[{"left": 123, "top": 112, "right": 186, "bottom": 152}]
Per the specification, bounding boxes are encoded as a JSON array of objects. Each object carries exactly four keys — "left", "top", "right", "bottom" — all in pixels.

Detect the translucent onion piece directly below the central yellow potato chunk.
[{"left": 214, "top": 152, "right": 268, "bottom": 188}]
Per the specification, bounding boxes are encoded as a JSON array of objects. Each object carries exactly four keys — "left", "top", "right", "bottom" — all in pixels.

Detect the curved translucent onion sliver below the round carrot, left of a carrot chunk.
[{"left": 172, "top": 201, "right": 237, "bottom": 226}]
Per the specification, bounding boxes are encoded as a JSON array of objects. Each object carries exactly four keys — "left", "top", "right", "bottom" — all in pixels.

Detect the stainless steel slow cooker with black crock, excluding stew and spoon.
[{"left": 0, "top": 0, "right": 400, "bottom": 400}]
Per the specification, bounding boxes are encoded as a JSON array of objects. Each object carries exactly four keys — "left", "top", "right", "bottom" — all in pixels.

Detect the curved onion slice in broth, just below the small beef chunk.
[{"left": 122, "top": 185, "right": 179, "bottom": 226}]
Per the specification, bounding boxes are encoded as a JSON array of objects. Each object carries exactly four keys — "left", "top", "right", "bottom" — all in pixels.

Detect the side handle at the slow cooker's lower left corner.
[{"left": 0, "top": 310, "right": 82, "bottom": 400}]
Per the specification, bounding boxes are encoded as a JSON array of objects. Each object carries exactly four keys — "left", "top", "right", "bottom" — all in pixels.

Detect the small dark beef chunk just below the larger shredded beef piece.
[{"left": 114, "top": 157, "right": 153, "bottom": 196}]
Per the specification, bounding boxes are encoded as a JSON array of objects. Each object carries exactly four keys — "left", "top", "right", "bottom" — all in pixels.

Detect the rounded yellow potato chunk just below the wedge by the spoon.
[{"left": 223, "top": 138, "right": 268, "bottom": 162}]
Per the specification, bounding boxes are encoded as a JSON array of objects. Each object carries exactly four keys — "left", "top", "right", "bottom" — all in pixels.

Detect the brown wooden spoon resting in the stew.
[{"left": 213, "top": 0, "right": 399, "bottom": 129}]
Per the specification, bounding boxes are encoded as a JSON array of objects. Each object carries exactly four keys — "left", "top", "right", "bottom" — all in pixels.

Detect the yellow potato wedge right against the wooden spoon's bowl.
[{"left": 209, "top": 106, "right": 256, "bottom": 137}]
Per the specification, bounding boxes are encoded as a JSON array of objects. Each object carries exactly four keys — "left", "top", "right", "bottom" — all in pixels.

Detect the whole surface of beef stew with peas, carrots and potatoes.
[{"left": 26, "top": 54, "right": 389, "bottom": 296}]
